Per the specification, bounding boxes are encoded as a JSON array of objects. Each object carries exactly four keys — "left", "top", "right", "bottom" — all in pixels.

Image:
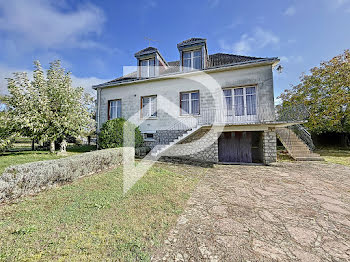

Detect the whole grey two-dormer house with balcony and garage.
[{"left": 94, "top": 38, "right": 322, "bottom": 164}]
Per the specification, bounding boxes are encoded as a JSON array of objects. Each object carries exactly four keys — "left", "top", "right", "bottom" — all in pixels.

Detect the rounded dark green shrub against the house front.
[{"left": 98, "top": 118, "right": 143, "bottom": 148}]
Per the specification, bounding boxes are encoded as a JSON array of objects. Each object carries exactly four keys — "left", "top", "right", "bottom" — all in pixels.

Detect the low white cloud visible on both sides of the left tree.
[{"left": 0, "top": 64, "right": 110, "bottom": 95}]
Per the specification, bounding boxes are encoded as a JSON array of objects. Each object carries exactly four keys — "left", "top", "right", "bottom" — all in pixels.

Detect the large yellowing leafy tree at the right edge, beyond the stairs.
[{"left": 279, "top": 50, "right": 350, "bottom": 145}]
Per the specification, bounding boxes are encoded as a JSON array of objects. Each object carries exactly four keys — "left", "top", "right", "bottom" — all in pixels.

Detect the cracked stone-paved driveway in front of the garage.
[{"left": 153, "top": 162, "right": 350, "bottom": 261}]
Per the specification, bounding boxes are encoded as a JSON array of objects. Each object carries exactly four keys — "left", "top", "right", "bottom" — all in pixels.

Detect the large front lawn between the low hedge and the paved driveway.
[{"left": 0, "top": 164, "right": 204, "bottom": 261}]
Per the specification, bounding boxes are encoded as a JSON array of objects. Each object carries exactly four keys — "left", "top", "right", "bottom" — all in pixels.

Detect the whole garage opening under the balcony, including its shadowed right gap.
[{"left": 218, "top": 131, "right": 262, "bottom": 163}]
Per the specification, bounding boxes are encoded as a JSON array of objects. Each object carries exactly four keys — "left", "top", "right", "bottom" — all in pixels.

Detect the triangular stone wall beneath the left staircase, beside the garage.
[{"left": 163, "top": 129, "right": 219, "bottom": 163}]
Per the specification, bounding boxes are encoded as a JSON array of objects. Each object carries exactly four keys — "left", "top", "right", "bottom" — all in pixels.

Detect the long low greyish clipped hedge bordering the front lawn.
[{"left": 0, "top": 148, "right": 134, "bottom": 202}]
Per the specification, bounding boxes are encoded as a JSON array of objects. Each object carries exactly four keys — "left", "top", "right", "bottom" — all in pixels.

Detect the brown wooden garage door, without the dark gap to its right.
[{"left": 219, "top": 132, "right": 252, "bottom": 163}]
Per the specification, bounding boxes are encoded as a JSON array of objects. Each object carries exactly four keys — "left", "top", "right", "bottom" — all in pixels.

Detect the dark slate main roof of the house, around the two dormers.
[{"left": 97, "top": 52, "right": 275, "bottom": 86}]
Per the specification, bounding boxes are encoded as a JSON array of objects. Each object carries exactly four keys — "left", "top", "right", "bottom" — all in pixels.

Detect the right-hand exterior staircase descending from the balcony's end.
[{"left": 276, "top": 128, "right": 324, "bottom": 161}]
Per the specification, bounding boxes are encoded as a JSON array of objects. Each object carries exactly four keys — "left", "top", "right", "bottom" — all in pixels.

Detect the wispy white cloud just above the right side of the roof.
[{"left": 219, "top": 27, "right": 280, "bottom": 55}]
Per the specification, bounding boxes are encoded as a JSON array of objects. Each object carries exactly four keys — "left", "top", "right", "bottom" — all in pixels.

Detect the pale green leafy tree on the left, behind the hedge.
[{"left": 5, "top": 61, "right": 93, "bottom": 152}]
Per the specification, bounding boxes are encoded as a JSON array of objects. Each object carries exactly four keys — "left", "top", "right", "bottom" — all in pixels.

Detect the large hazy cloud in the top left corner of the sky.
[{"left": 0, "top": 0, "right": 105, "bottom": 48}]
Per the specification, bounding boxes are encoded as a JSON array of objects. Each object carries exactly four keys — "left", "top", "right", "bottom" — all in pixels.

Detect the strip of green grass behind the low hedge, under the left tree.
[{"left": 0, "top": 146, "right": 96, "bottom": 175}]
